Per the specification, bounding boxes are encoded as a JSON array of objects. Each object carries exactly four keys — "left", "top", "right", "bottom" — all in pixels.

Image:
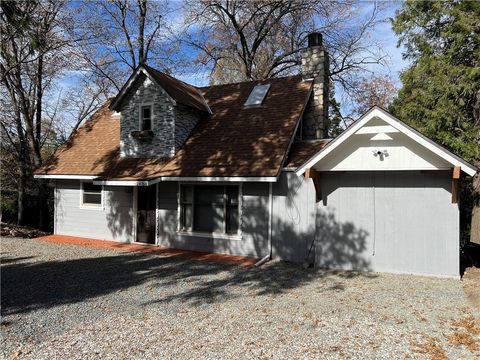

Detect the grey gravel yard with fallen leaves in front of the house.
[{"left": 1, "top": 238, "right": 480, "bottom": 360}]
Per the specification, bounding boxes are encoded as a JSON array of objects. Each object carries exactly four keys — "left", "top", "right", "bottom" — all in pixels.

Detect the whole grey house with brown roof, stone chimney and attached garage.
[{"left": 35, "top": 34, "right": 477, "bottom": 277}]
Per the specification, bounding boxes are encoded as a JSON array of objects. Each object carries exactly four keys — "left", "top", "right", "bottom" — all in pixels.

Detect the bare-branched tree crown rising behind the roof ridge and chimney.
[{"left": 183, "top": 0, "right": 383, "bottom": 91}]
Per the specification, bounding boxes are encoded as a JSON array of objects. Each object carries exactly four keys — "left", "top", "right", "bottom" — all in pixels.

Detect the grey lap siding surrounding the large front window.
[{"left": 158, "top": 182, "right": 268, "bottom": 257}]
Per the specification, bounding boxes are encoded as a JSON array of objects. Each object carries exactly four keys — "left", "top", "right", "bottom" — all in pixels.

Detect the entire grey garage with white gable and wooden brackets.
[{"left": 296, "top": 107, "right": 476, "bottom": 277}]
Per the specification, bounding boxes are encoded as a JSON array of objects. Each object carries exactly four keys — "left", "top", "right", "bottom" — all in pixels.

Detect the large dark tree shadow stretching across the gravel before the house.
[{"left": 1, "top": 253, "right": 375, "bottom": 315}]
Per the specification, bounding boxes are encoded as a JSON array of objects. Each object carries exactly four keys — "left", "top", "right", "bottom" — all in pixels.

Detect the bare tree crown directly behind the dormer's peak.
[{"left": 76, "top": 0, "right": 175, "bottom": 94}]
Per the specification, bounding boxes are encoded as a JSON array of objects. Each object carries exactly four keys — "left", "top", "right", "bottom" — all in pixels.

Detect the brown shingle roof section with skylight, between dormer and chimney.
[{"left": 158, "top": 76, "right": 311, "bottom": 177}]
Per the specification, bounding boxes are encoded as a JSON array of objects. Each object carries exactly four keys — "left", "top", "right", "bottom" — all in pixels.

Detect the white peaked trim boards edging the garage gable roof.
[{"left": 295, "top": 106, "right": 478, "bottom": 176}]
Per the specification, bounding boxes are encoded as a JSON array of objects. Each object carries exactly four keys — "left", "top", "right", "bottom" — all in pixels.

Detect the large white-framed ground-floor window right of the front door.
[{"left": 180, "top": 185, "right": 240, "bottom": 234}]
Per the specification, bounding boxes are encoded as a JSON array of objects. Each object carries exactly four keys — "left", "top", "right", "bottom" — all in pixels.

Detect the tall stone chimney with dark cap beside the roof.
[{"left": 301, "top": 33, "right": 329, "bottom": 140}]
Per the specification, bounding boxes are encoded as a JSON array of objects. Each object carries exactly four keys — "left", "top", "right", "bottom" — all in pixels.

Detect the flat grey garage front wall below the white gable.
[{"left": 315, "top": 171, "right": 459, "bottom": 276}]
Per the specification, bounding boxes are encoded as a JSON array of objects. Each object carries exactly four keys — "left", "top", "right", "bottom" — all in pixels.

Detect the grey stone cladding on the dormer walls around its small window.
[{"left": 120, "top": 75, "right": 200, "bottom": 158}]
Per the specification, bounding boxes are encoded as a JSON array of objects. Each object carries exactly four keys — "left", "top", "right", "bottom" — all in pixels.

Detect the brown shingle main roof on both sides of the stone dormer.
[{"left": 36, "top": 76, "right": 312, "bottom": 180}]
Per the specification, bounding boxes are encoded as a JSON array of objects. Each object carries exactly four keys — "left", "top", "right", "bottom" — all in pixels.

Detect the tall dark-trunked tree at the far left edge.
[{"left": 0, "top": 1, "right": 63, "bottom": 223}]
